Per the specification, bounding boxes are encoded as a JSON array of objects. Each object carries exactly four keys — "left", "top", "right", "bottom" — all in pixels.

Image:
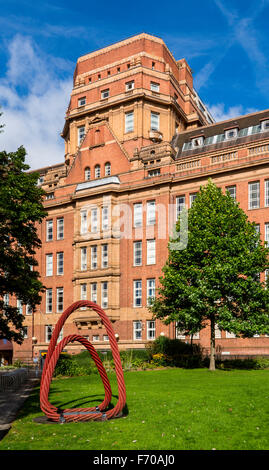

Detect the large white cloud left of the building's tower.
[{"left": 0, "top": 35, "right": 73, "bottom": 169}]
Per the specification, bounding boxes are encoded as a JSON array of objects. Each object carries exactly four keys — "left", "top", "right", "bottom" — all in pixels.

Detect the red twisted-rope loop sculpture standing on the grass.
[{"left": 40, "top": 300, "right": 126, "bottom": 423}]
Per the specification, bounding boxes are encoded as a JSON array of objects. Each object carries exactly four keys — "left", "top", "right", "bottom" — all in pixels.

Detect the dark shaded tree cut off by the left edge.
[{"left": 0, "top": 147, "right": 46, "bottom": 344}]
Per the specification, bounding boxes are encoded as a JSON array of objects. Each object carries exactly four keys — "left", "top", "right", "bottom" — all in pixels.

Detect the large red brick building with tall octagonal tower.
[{"left": 5, "top": 33, "right": 269, "bottom": 359}]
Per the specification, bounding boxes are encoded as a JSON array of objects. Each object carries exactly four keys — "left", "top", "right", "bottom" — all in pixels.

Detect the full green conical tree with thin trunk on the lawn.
[{"left": 151, "top": 180, "right": 269, "bottom": 370}]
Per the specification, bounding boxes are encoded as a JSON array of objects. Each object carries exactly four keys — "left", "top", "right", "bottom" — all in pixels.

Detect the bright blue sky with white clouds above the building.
[{"left": 0, "top": 0, "right": 269, "bottom": 168}]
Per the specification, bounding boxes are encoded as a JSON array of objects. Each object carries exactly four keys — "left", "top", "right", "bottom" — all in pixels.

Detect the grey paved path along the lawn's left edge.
[{"left": 0, "top": 372, "right": 40, "bottom": 440}]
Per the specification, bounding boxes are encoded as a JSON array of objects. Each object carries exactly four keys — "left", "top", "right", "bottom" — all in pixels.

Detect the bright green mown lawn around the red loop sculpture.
[{"left": 0, "top": 369, "right": 269, "bottom": 450}]
